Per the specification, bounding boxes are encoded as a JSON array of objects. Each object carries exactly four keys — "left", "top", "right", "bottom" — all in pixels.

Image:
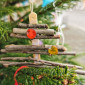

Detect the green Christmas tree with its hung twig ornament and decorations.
[{"left": 0, "top": 0, "right": 85, "bottom": 85}]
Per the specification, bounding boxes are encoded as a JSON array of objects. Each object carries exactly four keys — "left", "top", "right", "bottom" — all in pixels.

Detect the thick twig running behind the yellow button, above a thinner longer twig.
[{"left": 5, "top": 45, "right": 67, "bottom": 52}]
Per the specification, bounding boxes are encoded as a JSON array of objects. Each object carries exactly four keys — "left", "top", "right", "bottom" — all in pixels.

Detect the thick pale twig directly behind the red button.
[{"left": 13, "top": 28, "right": 54, "bottom": 36}]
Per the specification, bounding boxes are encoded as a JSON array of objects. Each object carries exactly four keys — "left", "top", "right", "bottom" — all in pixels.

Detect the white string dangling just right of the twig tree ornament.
[{"left": 53, "top": 1, "right": 65, "bottom": 45}]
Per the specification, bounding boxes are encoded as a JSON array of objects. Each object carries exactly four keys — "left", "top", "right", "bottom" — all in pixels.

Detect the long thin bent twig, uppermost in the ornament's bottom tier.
[{"left": 1, "top": 57, "right": 82, "bottom": 69}]
